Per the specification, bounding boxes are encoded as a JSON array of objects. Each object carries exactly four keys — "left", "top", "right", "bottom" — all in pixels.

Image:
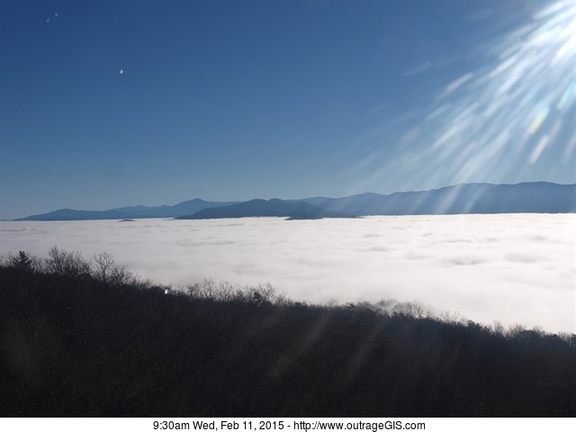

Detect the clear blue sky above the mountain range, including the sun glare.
[{"left": 0, "top": 0, "right": 576, "bottom": 219}]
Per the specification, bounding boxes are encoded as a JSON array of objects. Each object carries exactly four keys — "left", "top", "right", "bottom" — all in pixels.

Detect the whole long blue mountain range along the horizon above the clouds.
[{"left": 18, "top": 182, "right": 576, "bottom": 221}]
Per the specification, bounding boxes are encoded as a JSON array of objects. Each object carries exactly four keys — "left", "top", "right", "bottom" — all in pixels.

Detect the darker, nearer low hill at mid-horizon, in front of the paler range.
[{"left": 178, "top": 199, "right": 354, "bottom": 220}]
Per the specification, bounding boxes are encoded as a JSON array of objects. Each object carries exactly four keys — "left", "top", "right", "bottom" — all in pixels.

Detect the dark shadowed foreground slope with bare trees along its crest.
[{"left": 0, "top": 250, "right": 576, "bottom": 416}]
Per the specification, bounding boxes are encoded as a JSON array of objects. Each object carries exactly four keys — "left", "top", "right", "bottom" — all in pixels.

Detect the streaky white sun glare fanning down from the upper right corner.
[{"left": 354, "top": 0, "right": 576, "bottom": 196}]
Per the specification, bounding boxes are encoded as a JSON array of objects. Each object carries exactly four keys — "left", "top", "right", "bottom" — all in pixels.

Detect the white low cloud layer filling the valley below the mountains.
[{"left": 0, "top": 214, "right": 576, "bottom": 332}]
